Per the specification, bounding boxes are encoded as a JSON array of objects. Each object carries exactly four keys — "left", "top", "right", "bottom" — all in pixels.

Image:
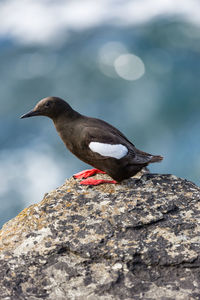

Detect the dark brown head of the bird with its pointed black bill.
[{"left": 20, "top": 97, "right": 73, "bottom": 119}]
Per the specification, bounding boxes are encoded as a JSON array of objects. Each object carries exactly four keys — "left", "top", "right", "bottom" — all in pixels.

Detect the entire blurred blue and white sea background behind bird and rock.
[{"left": 0, "top": 0, "right": 200, "bottom": 225}]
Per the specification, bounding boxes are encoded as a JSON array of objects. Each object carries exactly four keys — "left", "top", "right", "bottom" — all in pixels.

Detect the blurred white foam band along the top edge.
[{"left": 0, "top": 0, "right": 200, "bottom": 45}]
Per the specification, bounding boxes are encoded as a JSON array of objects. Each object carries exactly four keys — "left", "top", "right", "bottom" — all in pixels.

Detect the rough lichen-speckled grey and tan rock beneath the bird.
[{"left": 0, "top": 170, "right": 200, "bottom": 300}]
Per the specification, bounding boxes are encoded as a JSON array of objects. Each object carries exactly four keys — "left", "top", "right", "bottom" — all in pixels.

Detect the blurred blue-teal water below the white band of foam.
[{"left": 0, "top": 12, "right": 200, "bottom": 225}]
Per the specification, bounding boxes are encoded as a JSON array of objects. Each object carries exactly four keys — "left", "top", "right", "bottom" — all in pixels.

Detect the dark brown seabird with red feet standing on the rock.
[{"left": 20, "top": 97, "right": 163, "bottom": 185}]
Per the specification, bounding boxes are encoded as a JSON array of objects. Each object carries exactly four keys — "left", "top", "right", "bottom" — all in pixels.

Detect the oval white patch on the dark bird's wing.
[{"left": 89, "top": 142, "right": 128, "bottom": 159}]
